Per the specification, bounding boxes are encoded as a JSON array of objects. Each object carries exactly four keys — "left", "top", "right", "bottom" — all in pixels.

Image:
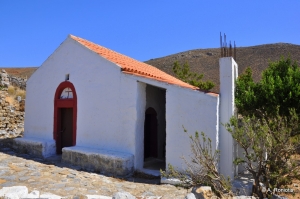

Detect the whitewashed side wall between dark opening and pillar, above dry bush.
[{"left": 166, "top": 87, "right": 219, "bottom": 169}]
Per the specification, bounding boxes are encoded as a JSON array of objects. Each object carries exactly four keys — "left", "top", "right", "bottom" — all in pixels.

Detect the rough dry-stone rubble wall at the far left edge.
[{"left": 0, "top": 91, "right": 25, "bottom": 138}]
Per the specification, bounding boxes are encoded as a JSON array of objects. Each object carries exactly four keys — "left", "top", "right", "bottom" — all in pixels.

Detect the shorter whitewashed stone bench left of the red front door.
[{"left": 13, "top": 138, "right": 56, "bottom": 158}]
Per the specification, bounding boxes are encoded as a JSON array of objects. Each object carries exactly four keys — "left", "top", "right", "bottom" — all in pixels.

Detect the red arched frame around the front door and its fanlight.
[{"left": 53, "top": 81, "right": 77, "bottom": 151}]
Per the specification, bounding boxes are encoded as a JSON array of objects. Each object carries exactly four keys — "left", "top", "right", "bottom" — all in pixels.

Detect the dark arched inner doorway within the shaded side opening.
[{"left": 144, "top": 107, "right": 157, "bottom": 159}]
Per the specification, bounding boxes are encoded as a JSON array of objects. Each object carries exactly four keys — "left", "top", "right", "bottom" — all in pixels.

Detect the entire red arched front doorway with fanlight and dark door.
[{"left": 53, "top": 81, "right": 77, "bottom": 154}]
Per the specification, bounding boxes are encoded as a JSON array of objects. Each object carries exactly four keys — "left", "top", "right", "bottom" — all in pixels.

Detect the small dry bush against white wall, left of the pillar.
[{"left": 161, "top": 129, "right": 232, "bottom": 197}]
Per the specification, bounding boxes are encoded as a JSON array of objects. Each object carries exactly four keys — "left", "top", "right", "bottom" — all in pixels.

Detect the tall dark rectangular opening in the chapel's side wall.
[{"left": 143, "top": 85, "right": 166, "bottom": 170}]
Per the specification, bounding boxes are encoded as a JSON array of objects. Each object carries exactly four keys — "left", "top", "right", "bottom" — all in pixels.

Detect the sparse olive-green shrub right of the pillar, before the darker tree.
[{"left": 225, "top": 108, "right": 300, "bottom": 198}]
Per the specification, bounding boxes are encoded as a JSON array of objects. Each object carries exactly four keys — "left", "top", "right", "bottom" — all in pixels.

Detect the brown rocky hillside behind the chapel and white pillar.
[{"left": 146, "top": 43, "right": 300, "bottom": 92}]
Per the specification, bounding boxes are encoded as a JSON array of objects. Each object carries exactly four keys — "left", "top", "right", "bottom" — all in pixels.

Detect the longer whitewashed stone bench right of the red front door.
[{"left": 62, "top": 146, "right": 134, "bottom": 176}]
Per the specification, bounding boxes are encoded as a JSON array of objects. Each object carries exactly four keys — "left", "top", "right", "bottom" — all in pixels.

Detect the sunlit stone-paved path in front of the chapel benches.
[{"left": 0, "top": 142, "right": 187, "bottom": 199}]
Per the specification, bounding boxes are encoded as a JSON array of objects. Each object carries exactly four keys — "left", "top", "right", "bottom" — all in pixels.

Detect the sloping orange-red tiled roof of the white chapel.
[{"left": 70, "top": 35, "right": 219, "bottom": 94}]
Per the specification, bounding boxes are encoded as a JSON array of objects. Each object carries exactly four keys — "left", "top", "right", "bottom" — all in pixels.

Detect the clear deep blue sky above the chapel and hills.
[{"left": 0, "top": 0, "right": 300, "bottom": 67}]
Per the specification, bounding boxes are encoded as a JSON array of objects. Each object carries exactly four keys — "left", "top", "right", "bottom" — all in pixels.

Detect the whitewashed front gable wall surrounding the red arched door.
[{"left": 24, "top": 35, "right": 138, "bottom": 157}]
